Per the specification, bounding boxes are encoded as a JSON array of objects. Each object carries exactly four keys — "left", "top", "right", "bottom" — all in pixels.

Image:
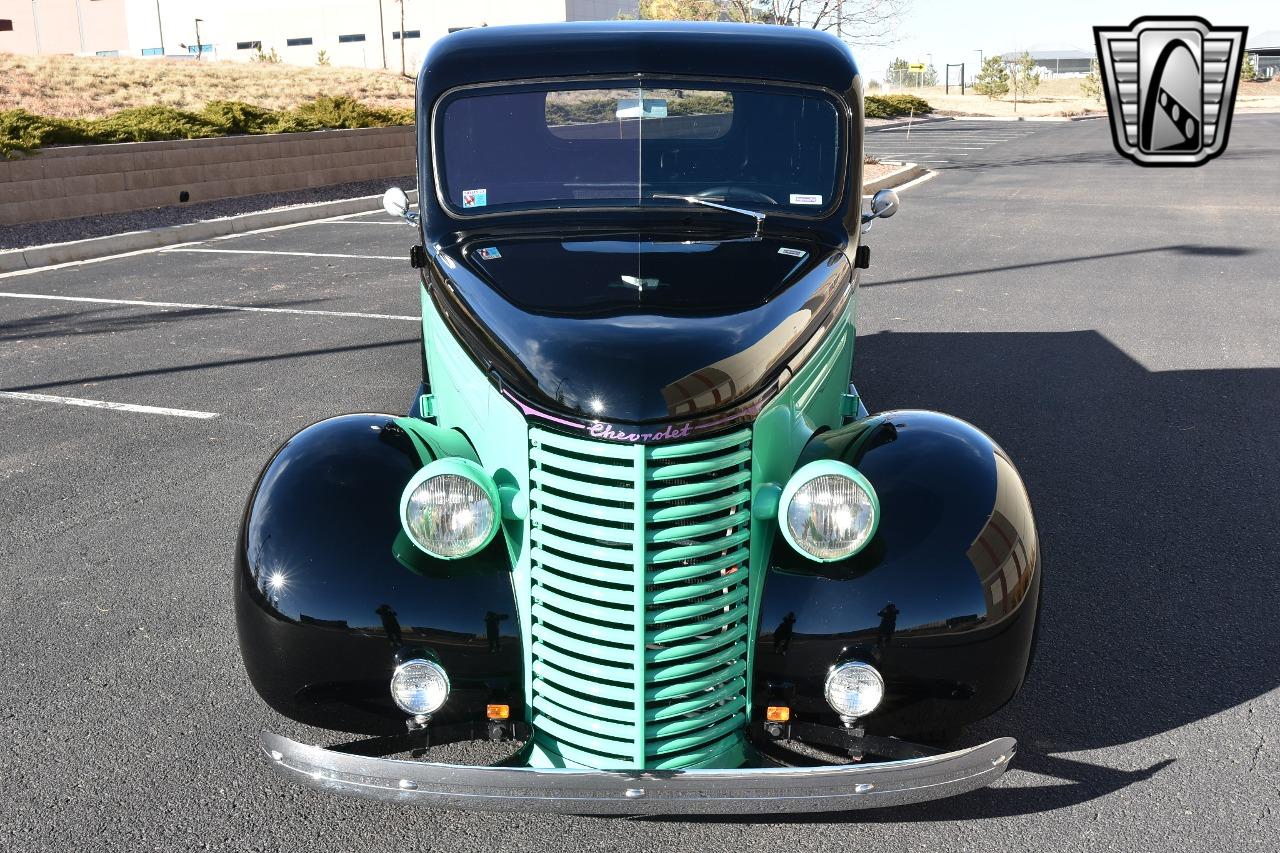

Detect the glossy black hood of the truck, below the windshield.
[{"left": 438, "top": 233, "right": 850, "bottom": 424}]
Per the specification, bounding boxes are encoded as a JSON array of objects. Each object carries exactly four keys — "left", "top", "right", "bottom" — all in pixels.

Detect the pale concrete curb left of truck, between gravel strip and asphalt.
[{"left": 0, "top": 190, "right": 417, "bottom": 273}]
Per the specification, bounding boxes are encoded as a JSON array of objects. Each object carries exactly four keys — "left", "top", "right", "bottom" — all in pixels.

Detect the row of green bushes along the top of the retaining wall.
[{"left": 0, "top": 96, "right": 413, "bottom": 158}]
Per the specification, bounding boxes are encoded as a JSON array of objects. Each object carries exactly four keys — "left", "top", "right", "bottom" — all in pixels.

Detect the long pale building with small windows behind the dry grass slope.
[{"left": 0, "top": 0, "right": 639, "bottom": 73}]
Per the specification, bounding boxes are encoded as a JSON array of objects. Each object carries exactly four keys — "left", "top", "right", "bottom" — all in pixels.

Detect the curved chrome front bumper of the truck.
[{"left": 261, "top": 733, "right": 1018, "bottom": 815}]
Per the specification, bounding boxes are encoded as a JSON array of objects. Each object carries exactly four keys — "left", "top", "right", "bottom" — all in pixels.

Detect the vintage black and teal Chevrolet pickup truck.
[{"left": 236, "top": 22, "right": 1041, "bottom": 815}]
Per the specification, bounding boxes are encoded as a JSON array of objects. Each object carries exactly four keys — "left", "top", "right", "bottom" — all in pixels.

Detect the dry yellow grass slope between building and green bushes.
[{"left": 0, "top": 54, "right": 413, "bottom": 118}]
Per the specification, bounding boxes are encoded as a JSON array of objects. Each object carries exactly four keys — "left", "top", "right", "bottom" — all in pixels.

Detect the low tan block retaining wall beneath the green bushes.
[{"left": 0, "top": 127, "right": 415, "bottom": 225}]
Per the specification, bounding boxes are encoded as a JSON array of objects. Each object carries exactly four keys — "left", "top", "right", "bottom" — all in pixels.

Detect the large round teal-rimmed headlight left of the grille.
[{"left": 401, "top": 457, "right": 502, "bottom": 560}]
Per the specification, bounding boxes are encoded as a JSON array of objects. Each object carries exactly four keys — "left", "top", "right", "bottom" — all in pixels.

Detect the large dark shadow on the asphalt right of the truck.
[{"left": 655, "top": 330, "right": 1280, "bottom": 822}]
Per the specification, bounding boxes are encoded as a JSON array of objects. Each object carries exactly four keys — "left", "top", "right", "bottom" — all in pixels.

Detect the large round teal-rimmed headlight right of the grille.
[{"left": 778, "top": 460, "right": 879, "bottom": 562}]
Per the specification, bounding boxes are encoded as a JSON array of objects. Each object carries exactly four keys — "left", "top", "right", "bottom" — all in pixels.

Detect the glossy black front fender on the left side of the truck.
[{"left": 234, "top": 414, "right": 522, "bottom": 734}]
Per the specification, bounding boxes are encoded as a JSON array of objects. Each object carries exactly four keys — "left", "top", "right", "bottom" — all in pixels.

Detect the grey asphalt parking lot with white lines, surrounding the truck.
[{"left": 0, "top": 115, "right": 1280, "bottom": 853}]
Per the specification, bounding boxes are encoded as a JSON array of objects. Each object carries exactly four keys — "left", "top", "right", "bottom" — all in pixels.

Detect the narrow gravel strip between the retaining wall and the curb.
[{"left": 0, "top": 175, "right": 416, "bottom": 250}]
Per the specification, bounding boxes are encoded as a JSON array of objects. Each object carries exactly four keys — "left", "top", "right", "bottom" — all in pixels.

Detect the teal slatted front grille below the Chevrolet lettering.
[{"left": 530, "top": 428, "right": 751, "bottom": 768}]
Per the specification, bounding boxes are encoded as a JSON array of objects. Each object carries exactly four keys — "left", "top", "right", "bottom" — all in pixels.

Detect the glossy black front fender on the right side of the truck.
[{"left": 755, "top": 411, "right": 1041, "bottom": 734}]
